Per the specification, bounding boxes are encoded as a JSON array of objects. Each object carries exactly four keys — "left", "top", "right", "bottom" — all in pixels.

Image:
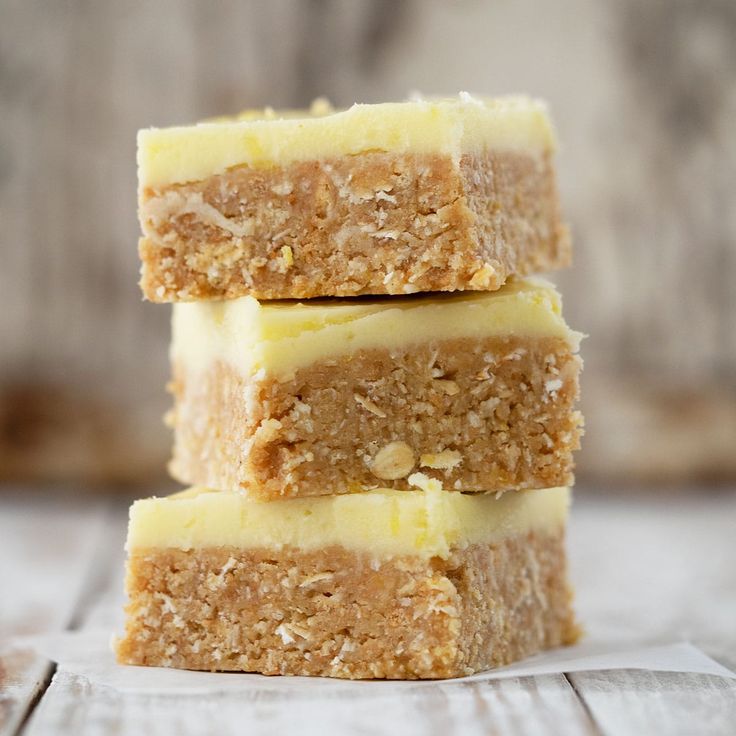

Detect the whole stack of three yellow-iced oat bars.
[{"left": 117, "top": 94, "right": 581, "bottom": 678}]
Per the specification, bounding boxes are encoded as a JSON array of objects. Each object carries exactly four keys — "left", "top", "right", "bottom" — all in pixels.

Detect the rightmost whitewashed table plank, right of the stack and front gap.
[{"left": 569, "top": 489, "right": 736, "bottom": 736}]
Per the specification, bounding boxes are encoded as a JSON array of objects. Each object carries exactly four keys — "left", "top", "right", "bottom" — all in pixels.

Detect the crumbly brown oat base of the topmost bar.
[{"left": 139, "top": 151, "right": 570, "bottom": 302}]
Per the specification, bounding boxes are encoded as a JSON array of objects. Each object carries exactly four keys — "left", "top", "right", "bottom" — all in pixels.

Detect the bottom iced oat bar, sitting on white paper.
[{"left": 117, "top": 473, "right": 578, "bottom": 679}]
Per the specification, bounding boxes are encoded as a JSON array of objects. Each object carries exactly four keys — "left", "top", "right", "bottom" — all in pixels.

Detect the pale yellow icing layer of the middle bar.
[{"left": 171, "top": 278, "right": 581, "bottom": 376}]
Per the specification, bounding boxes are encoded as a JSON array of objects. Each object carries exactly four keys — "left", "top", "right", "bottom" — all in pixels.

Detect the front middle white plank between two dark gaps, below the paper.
[{"left": 24, "top": 673, "right": 598, "bottom": 736}]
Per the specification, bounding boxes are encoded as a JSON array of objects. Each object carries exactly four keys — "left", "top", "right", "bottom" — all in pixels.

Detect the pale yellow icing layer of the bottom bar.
[{"left": 127, "top": 473, "right": 570, "bottom": 558}]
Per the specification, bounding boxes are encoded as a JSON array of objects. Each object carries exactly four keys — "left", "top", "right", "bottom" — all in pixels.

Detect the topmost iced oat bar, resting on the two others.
[{"left": 138, "top": 94, "right": 570, "bottom": 302}]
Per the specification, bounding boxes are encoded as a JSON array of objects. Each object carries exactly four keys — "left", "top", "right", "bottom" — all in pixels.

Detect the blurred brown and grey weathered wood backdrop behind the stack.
[{"left": 0, "top": 0, "right": 736, "bottom": 486}]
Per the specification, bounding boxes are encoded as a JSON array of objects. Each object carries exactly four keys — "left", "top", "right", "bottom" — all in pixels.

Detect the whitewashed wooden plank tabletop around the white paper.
[{"left": 0, "top": 489, "right": 736, "bottom": 736}]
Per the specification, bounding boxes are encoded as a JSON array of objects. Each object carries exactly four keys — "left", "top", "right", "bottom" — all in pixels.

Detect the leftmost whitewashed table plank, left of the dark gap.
[{"left": 0, "top": 495, "right": 112, "bottom": 736}]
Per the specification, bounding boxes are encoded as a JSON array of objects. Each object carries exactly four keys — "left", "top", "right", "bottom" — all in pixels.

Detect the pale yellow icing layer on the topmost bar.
[{"left": 138, "top": 93, "right": 555, "bottom": 187}]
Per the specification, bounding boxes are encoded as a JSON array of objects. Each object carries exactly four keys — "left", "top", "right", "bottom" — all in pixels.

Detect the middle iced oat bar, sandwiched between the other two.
[{"left": 169, "top": 279, "right": 581, "bottom": 499}]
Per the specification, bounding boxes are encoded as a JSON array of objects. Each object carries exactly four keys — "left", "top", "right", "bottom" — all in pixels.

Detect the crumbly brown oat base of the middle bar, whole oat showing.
[{"left": 169, "top": 336, "right": 582, "bottom": 500}]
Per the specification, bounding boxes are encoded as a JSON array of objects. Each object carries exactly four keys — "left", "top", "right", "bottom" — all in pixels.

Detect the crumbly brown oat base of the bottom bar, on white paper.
[{"left": 117, "top": 531, "right": 578, "bottom": 679}]
